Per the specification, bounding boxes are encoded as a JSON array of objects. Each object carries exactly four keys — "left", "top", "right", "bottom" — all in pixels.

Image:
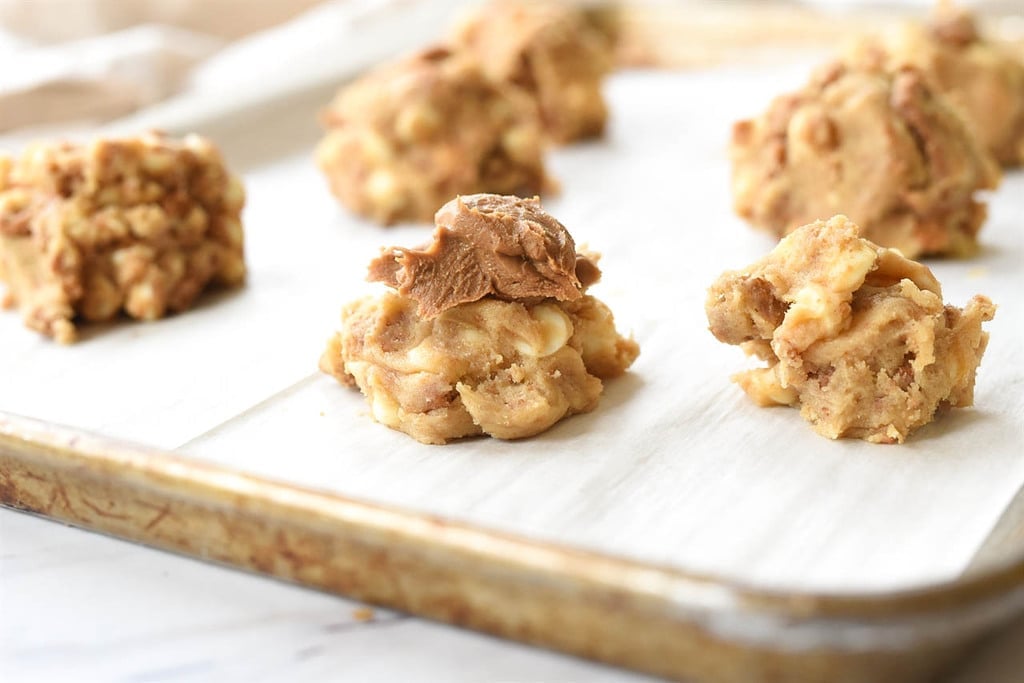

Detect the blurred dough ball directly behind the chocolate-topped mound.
[{"left": 316, "top": 48, "right": 549, "bottom": 224}]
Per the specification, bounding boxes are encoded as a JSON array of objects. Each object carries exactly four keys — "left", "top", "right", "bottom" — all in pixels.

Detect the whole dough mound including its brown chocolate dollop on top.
[{"left": 321, "top": 195, "right": 639, "bottom": 443}]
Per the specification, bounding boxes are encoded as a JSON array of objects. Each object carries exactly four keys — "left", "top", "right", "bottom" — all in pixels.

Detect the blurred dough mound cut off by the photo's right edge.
[{"left": 847, "top": 5, "right": 1024, "bottom": 166}]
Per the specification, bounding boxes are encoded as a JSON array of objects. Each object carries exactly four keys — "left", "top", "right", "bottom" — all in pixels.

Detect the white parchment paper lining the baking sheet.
[{"left": 0, "top": 66, "right": 1024, "bottom": 591}]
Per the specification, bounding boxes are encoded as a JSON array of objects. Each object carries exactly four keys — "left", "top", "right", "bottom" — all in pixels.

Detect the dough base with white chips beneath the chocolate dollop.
[{"left": 321, "top": 292, "right": 639, "bottom": 443}]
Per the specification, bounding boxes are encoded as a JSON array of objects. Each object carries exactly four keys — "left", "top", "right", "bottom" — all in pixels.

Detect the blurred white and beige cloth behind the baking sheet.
[{"left": 0, "top": 0, "right": 436, "bottom": 132}]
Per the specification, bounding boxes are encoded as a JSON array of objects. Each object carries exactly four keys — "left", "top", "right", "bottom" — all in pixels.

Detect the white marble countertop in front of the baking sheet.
[{"left": 0, "top": 510, "right": 1024, "bottom": 683}]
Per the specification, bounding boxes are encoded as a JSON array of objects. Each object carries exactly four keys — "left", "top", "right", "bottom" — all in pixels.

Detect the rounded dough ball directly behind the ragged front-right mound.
[{"left": 731, "top": 63, "right": 999, "bottom": 258}]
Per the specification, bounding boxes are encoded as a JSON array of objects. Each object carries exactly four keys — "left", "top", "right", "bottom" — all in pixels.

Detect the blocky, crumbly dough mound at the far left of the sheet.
[{"left": 0, "top": 134, "right": 246, "bottom": 343}]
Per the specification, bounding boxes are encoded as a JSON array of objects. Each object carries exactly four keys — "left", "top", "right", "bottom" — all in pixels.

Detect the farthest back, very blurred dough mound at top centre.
[{"left": 452, "top": 1, "right": 611, "bottom": 142}]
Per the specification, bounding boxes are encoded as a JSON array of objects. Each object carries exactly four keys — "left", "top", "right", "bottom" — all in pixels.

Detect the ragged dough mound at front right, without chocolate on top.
[{"left": 707, "top": 216, "right": 995, "bottom": 443}]
